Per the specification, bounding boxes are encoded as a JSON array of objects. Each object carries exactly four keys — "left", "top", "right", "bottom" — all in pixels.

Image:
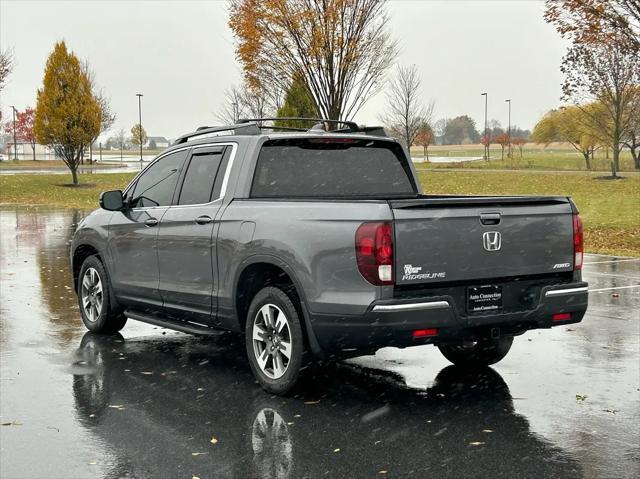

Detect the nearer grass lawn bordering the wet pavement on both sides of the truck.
[{"left": 0, "top": 170, "right": 640, "bottom": 256}]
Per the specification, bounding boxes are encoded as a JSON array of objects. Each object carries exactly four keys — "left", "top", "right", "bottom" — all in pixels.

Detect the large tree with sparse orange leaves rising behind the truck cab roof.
[{"left": 229, "top": 0, "right": 397, "bottom": 120}]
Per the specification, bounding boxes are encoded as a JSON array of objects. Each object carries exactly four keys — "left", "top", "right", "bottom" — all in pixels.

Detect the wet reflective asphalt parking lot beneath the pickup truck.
[{"left": 0, "top": 207, "right": 640, "bottom": 479}]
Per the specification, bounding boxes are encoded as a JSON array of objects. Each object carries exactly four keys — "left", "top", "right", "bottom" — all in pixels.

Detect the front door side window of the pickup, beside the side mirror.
[{"left": 131, "top": 150, "right": 188, "bottom": 208}]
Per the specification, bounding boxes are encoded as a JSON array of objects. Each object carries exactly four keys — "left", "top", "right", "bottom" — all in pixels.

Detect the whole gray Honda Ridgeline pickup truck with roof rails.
[{"left": 71, "top": 120, "right": 588, "bottom": 394}]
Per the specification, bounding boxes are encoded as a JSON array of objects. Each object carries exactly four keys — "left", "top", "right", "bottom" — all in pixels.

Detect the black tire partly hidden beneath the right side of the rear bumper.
[{"left": 438, "top": 336, "right": 513, "bottom": 368}]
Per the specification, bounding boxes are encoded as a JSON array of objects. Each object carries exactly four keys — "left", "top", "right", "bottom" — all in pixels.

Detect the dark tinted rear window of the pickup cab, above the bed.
[{"left": 251, "top": 138, "right": 416, "bottom": 198}]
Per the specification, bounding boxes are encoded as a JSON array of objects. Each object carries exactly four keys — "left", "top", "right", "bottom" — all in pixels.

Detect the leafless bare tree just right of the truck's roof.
[{"left": 380, "top": 65, "right": 434, "bottom": 148}]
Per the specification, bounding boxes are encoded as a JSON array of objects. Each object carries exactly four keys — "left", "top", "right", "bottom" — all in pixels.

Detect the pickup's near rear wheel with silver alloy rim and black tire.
[{"left": 245, "top": 286, "right": 304, "bottom": 394}]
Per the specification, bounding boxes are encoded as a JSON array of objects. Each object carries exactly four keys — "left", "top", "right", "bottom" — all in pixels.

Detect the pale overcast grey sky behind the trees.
[{"left": 0, "top": 0, "right": 566, "bottom": 138}]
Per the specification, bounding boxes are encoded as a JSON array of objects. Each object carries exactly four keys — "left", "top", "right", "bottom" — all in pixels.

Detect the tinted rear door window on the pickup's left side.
[{"left": 178, "top": 147, "right": 225, "bottom": 205}]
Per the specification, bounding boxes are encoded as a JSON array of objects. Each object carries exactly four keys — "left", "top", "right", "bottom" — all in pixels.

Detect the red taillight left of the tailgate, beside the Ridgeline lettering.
[{"left": 356, "top": 222, "right": 393, "bottom": 286}]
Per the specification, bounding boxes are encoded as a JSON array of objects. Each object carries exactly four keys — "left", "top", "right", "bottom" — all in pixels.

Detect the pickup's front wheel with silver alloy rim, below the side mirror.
[{"left": 77, "top": 255, "right": 127, "bottom": 334}]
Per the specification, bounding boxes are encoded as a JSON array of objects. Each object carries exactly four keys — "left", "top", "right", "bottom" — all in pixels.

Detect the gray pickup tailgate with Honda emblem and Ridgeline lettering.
[{"left": 389, "top": 196, "right": 573, "bottom": 285}]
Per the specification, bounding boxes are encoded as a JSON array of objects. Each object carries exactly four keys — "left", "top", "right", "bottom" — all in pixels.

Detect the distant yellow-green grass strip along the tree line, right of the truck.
[{"left": 411, "top": 143, "right": 638, "bottom": 171}]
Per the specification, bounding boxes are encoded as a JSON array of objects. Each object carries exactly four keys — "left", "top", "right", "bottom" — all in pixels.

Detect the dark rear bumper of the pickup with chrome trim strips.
[{"left": 310, "top": 282, "right": 589, "bottom": 352}]
